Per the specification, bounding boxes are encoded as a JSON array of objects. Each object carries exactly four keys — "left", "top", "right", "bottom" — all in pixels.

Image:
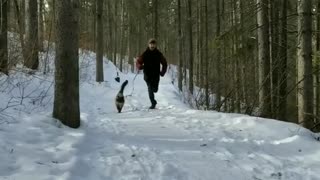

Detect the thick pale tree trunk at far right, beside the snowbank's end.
[{"left": 297, "top": 0, "right": 314, "bottom": 129}]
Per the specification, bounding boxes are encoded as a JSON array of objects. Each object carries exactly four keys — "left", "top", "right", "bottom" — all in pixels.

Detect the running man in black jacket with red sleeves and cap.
[{"left": 136, "top": 39, "right": 167, "bottom": 109}]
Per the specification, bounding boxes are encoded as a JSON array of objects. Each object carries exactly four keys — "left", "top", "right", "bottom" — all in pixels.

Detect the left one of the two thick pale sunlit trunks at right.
[{"left": 257, "top": 0, "right": 271, "bottom": 117}]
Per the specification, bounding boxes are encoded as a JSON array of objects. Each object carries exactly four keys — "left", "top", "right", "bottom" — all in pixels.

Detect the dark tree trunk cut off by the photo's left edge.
[{"left": 0, "top": 0, "right": 9, "bottom": 74}]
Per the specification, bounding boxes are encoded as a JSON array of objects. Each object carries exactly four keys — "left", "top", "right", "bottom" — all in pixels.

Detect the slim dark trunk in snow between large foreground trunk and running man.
[{"left": 96, "top": 0, "right": 104, "bottom": 82}]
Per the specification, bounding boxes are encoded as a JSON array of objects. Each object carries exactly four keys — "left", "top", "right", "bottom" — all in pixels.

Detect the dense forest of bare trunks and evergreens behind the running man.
[{"left": 0, "top": 0, "right": 320, "bottom": 130}]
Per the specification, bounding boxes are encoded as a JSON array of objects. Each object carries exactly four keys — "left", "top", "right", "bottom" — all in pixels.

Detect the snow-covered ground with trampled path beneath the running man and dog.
[{"left": 0, "top": 49, "right": 320, "bottom": 180}]
